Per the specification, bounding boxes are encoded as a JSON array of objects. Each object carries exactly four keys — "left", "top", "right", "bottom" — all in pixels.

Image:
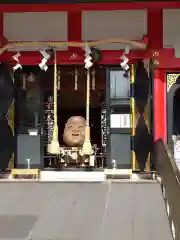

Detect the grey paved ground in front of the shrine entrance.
[{"left": 0, "top": 182, "right": 172, "bottom": 240}]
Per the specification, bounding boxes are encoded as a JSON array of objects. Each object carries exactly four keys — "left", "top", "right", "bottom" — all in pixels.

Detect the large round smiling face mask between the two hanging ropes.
[{"left": 63, "top": 116, "right": 86, "bottom": 147}]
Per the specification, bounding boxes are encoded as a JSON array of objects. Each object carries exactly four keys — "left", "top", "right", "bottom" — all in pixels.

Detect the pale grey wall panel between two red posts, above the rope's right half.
[{"left": 82, "top": 10, "right": 147, "bottom": 50}]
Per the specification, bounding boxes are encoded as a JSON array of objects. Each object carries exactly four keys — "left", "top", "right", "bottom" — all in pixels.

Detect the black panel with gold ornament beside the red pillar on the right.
[{"left": 134, "top": 61, "right": 152, "bottom": 171}]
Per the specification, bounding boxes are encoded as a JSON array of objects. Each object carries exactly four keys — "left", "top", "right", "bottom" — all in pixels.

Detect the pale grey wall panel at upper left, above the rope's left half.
[{"left": 4, "top": 12, "right": 67, "bottom": 49}]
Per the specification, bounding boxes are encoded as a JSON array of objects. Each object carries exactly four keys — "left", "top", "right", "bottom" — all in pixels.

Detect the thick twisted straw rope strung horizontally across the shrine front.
[{"left": 0, "top": 38, "right": 146, "bottom": 55}]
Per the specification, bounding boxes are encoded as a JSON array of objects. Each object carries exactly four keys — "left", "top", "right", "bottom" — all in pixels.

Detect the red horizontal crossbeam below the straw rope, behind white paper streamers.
[{"left": 0, "top": 48, "right": 180, "bottom": 69}]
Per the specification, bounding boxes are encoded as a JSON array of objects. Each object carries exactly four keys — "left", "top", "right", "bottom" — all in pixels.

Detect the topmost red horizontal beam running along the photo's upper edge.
[{"left": 0, "top": 1, "right": 180, "bottom": 12}]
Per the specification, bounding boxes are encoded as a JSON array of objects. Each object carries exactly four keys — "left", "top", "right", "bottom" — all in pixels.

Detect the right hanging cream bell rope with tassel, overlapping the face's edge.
[{"left": 82, "top": 68, "right": 93, "bottom": 155}]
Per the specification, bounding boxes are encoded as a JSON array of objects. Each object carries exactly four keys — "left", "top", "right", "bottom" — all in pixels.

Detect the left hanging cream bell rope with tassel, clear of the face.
[{"left": 48, "top": 52, "right": 60, "bottom": 154}]
